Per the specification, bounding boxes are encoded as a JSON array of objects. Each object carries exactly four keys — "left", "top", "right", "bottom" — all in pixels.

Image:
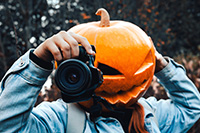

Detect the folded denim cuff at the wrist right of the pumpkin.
[{"left": 155, "top": 57, "right": 185, "bottom": 82}]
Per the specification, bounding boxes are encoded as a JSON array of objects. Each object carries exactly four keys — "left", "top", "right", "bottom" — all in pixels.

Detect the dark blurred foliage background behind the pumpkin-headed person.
[{"left": 0, "top": 0, "right": 200, "bottom": 133}]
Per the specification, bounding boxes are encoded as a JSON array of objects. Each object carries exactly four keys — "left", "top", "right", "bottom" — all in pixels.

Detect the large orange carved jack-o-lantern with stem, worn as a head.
[{"left": 69, "top": 8, "right": 155, "bottom": 104}]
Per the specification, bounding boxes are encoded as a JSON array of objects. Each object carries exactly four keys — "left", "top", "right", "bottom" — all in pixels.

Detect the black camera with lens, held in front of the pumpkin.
[{"left": 55, "top": 45, "right": 103, "bottom": 103}]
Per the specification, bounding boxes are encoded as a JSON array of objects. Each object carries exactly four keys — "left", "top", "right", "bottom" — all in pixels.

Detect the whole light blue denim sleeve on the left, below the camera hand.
[{"left": 0, "top": 51, "right": 66, "bottom": 132}]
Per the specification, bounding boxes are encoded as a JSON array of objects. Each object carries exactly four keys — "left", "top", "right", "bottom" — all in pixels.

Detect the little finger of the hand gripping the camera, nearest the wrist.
[{"left": 47, "top": 41, "right": 62, "bottom": 61}]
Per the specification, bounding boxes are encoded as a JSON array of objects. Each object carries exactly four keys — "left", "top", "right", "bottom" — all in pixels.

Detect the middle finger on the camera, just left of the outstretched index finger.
[{"left": 62, "top": 32, "right": 79, "bottom": 58}]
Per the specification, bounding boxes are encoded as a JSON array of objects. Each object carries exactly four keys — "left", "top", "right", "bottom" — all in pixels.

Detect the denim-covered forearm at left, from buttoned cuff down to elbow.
[{"left": 0, "top": 51, "right": 51, "bottom": 132}]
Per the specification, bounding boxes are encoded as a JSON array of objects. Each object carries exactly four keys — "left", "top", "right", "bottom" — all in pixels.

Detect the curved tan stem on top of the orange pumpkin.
[{"left": 96, "top": 8, "right": 110, "bottom": 27}]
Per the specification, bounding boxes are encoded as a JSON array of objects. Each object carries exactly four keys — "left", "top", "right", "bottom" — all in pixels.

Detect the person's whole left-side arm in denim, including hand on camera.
[{"left": 0, "top": 31, "right": 94, "bottom": 132}]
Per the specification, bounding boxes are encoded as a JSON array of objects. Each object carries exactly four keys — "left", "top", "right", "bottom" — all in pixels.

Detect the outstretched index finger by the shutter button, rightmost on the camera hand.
[{"left": 69, "top": 32, "right": 95, "bottom": 55}]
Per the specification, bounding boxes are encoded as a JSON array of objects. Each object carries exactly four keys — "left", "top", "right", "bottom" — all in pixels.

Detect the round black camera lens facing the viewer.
[{"left": 55, "top": 59, "right": 92, "bottom": 96}]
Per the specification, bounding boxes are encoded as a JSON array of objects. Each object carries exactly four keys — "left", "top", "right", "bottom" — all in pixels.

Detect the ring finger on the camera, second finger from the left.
[{"left": 53, "top": 34, "right": 71, "bottom": 60}]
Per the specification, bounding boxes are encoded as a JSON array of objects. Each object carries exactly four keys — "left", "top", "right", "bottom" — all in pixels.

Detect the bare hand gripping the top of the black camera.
[{"left": 34, "top": 31, "right": 95, "bottom": 62}]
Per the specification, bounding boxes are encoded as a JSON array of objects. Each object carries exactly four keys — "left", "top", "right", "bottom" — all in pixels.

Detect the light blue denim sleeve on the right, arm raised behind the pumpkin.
[{"left": 148, "top": 58, "right": 200, "bottom": 133}]
